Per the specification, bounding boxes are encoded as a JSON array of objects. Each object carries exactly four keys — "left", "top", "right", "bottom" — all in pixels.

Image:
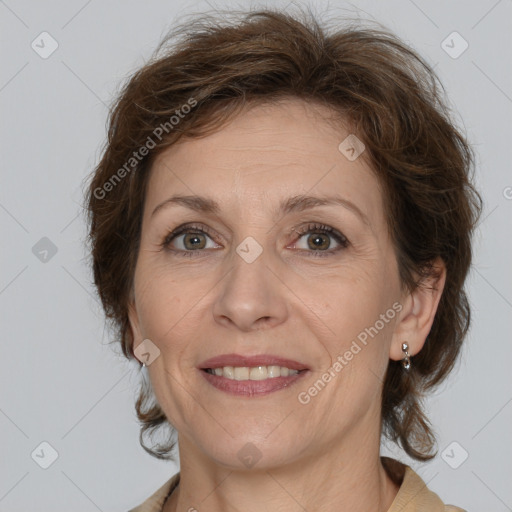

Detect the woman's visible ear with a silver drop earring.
[{"left": 389, "top": 258, "right": 446, "bottom": 361}]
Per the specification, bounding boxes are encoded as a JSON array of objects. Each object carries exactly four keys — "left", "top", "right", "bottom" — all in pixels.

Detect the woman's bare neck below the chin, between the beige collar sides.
[{"left": 164, "top": 436, "right": 399, "bottom": 512}]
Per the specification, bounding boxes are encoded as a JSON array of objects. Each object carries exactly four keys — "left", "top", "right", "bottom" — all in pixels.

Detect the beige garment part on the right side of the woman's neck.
[{"left": 385, "top": 460, "right": 466, "bottom": 512}]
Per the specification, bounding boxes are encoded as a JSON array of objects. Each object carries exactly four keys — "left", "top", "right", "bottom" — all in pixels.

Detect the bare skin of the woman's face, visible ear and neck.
[{"left": 129, "top": 98, "right": 445, "bottom": 512}]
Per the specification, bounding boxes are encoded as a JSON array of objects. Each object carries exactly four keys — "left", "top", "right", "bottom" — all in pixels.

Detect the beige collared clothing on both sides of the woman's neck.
[{"left": 130, "top": 457, "right": 466, "bottom": 512}]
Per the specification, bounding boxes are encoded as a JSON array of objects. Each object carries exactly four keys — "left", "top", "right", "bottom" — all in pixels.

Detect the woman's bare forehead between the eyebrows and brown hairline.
[{"left": 146, "top": 99, "right": 382, "bottom": 227}]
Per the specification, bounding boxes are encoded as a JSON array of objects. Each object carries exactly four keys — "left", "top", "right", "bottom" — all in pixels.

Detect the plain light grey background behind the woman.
[{"left": 0, "top": 0, "right": 512, "bottom": 512}]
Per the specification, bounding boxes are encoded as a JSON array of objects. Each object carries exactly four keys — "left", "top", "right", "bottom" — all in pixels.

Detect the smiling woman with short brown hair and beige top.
[{"left": 88, "top": 11, "right": 481, "bottom": 512}]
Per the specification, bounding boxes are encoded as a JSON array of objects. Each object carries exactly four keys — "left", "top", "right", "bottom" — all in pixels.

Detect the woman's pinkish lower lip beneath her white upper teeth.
[{"left": 200, "top": 370, "right": 308, "bottom": 396}]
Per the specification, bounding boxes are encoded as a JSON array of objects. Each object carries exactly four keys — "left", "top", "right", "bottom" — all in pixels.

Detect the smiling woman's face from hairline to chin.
[{"left": 130, "top": 99, "right": 410, "bottom": 468}]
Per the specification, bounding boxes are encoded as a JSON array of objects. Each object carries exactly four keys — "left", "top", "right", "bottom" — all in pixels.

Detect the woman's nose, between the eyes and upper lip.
[{"left": 213, "top": 251, "right": 288, "bottom": 332}]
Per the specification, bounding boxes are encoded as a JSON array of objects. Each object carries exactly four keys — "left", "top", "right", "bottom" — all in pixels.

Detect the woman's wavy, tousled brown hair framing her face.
[{"left": 87, "top": 10, "right": 482, "bottom": 460}]
